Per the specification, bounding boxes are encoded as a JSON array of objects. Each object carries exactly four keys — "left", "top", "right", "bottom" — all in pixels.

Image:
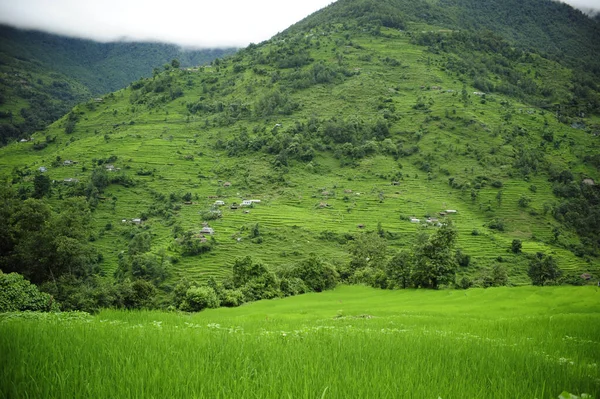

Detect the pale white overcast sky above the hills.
[{"left": 0, "top": 0, "right": 600, "bottom": 47}]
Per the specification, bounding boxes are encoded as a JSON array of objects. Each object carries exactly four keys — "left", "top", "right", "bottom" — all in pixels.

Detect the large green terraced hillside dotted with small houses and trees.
[{"left": 0, "top": 1, "right": 600, "bottom": 310}]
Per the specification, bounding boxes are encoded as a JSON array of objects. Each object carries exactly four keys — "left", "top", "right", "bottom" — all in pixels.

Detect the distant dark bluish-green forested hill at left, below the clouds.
[{"left": 0, "top": 25, "right": 234, "bottom": 145}]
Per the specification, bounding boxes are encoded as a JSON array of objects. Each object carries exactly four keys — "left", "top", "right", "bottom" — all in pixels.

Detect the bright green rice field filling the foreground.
[{"left": 0, "top": 286, "right": 600, "bottom": 399}]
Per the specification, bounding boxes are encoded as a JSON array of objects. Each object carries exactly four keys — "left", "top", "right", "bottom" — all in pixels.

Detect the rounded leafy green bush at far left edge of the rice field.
[{"left": 0, "top": 270, "right": 58, "bottom": 312}]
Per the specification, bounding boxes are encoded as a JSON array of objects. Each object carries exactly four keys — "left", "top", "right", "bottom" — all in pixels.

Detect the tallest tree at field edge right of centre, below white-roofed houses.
[{"left": 412, "top": 222, "right": 458, "bottom": 289}]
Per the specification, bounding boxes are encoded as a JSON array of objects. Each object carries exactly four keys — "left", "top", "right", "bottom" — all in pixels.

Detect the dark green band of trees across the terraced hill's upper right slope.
[{"left": 412, "top": 31, "right": 600, "bottom": 117}]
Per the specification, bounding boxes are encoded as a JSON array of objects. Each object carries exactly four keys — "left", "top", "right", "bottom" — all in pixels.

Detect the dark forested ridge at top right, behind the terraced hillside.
[{"left": 284, "top": 0, "right": 600, "bottom": 67}]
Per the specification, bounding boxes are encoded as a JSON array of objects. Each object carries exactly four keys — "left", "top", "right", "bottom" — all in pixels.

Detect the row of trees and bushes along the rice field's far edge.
[{"left": 0, "top": 203, "right": 581, "bottom": 312}]
